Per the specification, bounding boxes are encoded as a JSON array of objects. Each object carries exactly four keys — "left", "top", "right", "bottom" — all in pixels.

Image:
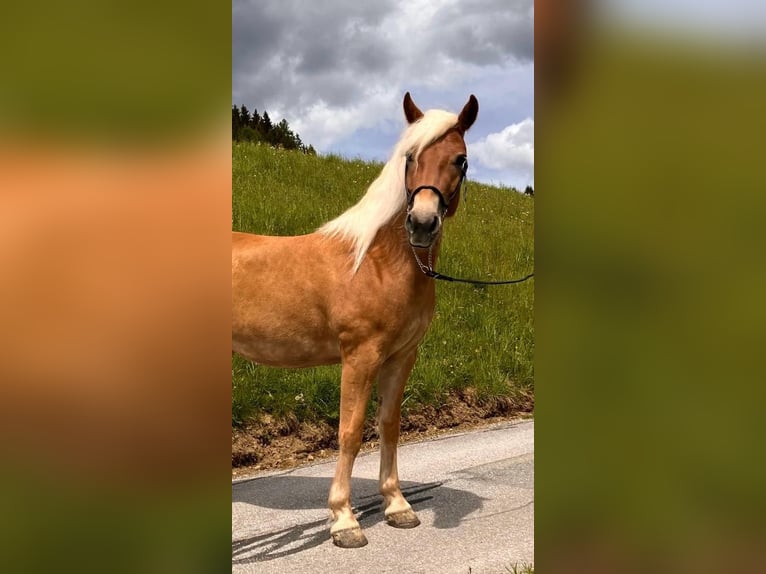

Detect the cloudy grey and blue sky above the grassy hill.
[{"left": 232, "top": 0, "right": 534, "bottom": 189}]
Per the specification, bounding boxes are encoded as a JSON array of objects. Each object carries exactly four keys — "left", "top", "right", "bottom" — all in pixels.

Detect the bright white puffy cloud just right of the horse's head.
[{"left": 468, "top": 118, "right": 535, "bottom": 187}]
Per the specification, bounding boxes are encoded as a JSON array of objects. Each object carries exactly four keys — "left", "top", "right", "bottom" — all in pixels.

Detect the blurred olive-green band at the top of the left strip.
[{"left": 0, "top": 0, "right": 231, "bottom": 141}]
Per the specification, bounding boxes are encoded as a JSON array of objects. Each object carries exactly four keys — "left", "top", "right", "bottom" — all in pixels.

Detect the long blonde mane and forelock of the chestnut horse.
[{"left": 319, "top": 110, "right": 458, "bottom": 273}]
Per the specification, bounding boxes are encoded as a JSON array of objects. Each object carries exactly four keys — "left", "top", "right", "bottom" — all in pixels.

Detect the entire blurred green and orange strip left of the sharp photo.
[{"left": 0, "top": 0, "right": 231, "bottom": 572}]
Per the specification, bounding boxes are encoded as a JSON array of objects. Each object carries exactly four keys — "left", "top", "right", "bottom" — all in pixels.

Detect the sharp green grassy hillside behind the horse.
[{"left": 232, "top": 142, "right": 534, "bottom": 425}]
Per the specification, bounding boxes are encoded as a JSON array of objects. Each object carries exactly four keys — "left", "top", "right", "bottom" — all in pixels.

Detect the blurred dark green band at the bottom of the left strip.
[{"left": 0, "top": 472, "right": 230, "bottom": 574}]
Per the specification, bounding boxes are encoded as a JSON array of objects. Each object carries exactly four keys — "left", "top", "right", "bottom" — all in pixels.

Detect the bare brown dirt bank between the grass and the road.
[{"left": 231, "top": 389, "right": 534, "bottom": 478}]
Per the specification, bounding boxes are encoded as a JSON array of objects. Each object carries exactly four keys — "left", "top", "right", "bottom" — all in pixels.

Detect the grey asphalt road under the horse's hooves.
[{"left": 232, "top": 421, "right": 534, "bottom": 574}]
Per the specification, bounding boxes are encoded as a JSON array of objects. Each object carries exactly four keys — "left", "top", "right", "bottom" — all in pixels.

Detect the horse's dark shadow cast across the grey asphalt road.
[{"left": 232, "top": 476, "right": 484, "bottom": 564}]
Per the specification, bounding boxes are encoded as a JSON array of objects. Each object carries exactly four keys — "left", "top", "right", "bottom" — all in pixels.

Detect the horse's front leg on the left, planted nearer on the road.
[{"left": 328, "top": 349, "right": 380, "bottom": 548}]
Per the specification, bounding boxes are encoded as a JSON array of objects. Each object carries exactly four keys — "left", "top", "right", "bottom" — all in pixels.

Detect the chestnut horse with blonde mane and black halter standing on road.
[{"left": 231, "top": 92, "right": 479, "bottom": 548}]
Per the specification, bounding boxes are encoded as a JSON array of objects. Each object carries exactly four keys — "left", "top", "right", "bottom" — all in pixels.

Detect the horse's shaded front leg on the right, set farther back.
[{"left": 378, "top": 349, "right": 420, "bottom": 528}]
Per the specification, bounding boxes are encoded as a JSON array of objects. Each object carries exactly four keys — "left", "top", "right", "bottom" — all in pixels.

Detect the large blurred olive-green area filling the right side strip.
[{"left": 535, "top": 25, "right": 766, "bottom": 572}]
